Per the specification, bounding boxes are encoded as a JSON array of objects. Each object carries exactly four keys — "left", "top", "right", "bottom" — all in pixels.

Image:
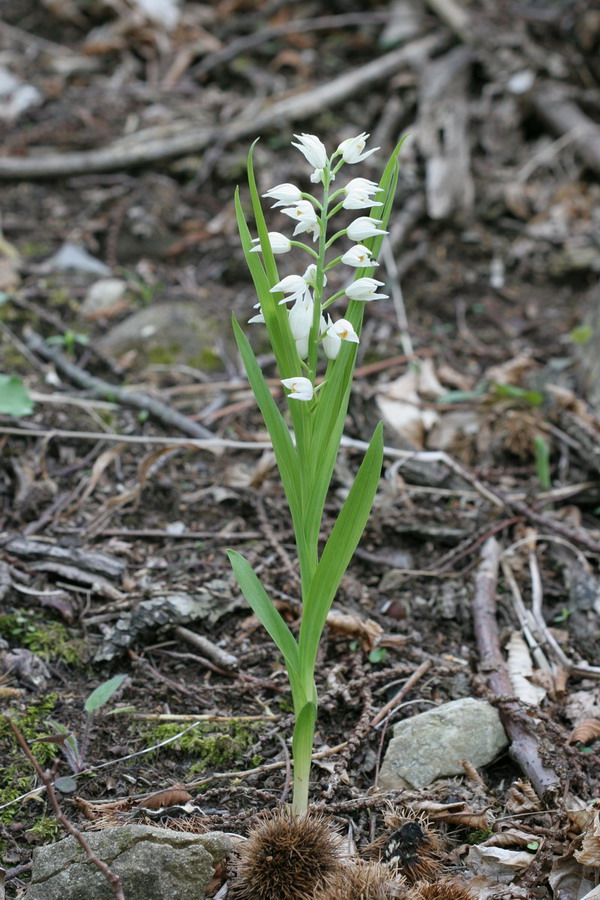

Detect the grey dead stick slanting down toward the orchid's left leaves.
[{"left": 25, "top": 329, "right": 214, "bottom": 439}]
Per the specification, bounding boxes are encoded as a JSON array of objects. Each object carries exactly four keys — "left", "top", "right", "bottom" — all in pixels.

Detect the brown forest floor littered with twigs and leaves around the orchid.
[{"left": 0, "top": 0, "right": 600, "bottom": 900}]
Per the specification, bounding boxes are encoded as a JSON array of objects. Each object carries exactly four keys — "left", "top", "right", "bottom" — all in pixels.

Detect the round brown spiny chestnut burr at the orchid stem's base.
[{"left": 232, "top": 809, "right": 344, "bottom": 900}]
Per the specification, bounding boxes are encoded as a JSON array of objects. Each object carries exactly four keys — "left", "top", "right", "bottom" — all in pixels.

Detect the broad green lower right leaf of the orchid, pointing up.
[{"left": 298, "top": 423, "right": 383, "bottom": 673}]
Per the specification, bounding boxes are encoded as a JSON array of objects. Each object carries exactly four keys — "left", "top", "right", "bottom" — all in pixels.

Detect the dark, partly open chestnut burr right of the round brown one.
[{"left": 382, "top": 819, "right": 441, "bottom": 884}]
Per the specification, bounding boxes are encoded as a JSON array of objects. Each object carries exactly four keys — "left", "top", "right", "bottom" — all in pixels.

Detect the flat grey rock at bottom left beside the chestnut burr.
[{"left": 26, "top": 825, "right": 231, "bottom": 900}]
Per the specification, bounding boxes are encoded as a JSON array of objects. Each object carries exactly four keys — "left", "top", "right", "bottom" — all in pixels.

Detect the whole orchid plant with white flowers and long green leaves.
[{"left": 228, "top": 133, "right": 402, "bottom": 814}]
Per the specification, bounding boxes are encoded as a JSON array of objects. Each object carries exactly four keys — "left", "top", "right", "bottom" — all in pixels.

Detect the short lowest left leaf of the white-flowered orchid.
[{"left": 227, "top": 550, "right": 302, "bottom": 708}]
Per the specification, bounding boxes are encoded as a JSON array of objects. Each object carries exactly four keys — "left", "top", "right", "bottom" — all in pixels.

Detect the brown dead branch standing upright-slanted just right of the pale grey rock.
[{"left": 473, "top": 538, "right": 561, "bottom": 803}]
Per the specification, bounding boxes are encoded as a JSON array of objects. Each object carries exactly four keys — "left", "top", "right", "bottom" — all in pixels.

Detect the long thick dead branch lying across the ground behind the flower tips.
[{"left": 0, "top": 34, "right": 447, "bottom": 180}]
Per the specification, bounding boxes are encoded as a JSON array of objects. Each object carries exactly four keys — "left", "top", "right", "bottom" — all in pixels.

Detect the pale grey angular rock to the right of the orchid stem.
[{"left": 379, "top": 697, "right": 508, "bottom": 790}]
